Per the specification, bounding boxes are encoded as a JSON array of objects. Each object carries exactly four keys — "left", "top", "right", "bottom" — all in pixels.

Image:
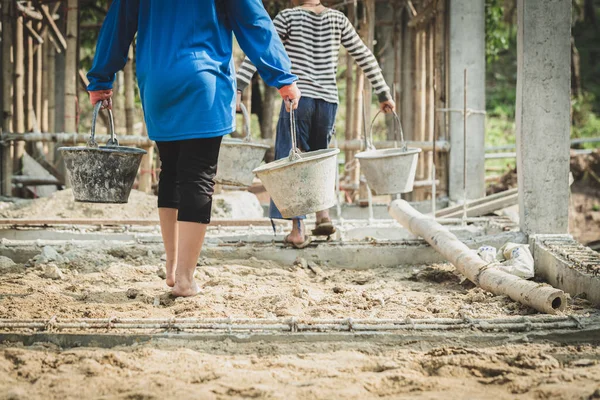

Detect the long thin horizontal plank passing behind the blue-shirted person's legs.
[{"left": 0, "top": 218, "right": 289, "bottom": 227}]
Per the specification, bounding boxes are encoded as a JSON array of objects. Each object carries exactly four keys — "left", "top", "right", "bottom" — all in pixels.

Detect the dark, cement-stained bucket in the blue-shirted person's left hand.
[{"left": 58, "top": 102, "right": 146, "bottom": 203}]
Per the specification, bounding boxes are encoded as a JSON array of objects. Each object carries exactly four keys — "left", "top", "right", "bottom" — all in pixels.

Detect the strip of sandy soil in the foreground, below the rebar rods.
[{"left": 0, "top": 341, "right": 600, "bottom": 400}]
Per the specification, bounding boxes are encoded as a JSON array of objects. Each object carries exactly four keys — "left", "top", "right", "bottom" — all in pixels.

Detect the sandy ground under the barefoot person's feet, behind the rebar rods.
[{"left": 0, "top": 245, "right": 587, "bottom": 318}]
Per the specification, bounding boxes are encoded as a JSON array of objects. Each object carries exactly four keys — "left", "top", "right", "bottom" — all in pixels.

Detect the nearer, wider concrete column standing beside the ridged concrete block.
[{"left": 516, "top": 0, "right": 571, "bottom": 234}]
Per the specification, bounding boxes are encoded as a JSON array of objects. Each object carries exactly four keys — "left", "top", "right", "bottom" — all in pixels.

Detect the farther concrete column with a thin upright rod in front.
[{"left": 449, "top": 0, "right": 485, "bottom": 201}]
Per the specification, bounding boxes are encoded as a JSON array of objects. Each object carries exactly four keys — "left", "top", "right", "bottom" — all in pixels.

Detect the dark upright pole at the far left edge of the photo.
[{"left": 0, "top": 0, "right": 14, "bottom": 196}]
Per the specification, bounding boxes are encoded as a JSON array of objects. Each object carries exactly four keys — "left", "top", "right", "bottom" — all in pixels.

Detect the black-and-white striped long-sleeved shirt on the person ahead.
[{"left": 237, "top": 7, "right": 391, "bottom": 104}]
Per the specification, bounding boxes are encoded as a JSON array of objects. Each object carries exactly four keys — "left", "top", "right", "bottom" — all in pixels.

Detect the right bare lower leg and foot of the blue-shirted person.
[{"left": 173, "top": 221, "right": 208, "bottom": 297}]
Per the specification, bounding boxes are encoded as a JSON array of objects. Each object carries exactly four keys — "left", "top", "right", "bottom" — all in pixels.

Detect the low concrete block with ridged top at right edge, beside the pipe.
[{"left": 530, "top": 235, "right": 600, "bottom": 307}]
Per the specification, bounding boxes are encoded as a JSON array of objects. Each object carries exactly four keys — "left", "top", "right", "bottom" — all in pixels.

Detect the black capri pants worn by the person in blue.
[{"left": 156, "top": 136, "right": 222, "bottom": 224}]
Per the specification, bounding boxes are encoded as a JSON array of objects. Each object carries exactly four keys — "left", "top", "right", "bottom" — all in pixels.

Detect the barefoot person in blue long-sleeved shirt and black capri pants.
[{"left": 87, "top": 0, "right": 300, "bottom": 296}]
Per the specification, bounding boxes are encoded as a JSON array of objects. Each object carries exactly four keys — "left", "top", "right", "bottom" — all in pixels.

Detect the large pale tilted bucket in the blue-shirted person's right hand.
[{"left": 254, "top": 101, "right": 340, "bottom": 218}]
